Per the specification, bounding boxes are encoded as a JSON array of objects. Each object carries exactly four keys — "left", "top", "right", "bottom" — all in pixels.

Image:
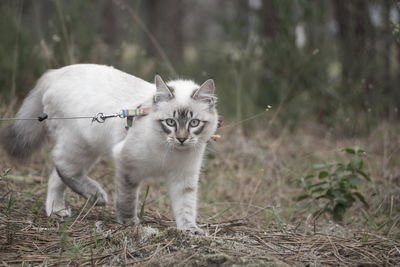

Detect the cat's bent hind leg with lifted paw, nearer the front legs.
[{"left": 52, "top": 142, "right": 107, "bottom": 206}]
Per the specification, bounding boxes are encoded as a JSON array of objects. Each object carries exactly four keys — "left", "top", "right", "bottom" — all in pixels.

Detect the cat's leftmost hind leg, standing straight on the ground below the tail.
[{"left": 46, "top": 169, "right": 71, "bottom": 217}]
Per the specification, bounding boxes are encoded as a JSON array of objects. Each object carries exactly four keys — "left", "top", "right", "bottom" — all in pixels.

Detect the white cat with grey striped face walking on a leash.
[{"left": 1, "top": 64, "right": 218, "bottom": 234}]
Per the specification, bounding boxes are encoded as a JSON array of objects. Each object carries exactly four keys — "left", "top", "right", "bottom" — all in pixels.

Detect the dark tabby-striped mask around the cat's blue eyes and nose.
[{"left": 160, "top": 109, "right": 206, "bottom": 145}]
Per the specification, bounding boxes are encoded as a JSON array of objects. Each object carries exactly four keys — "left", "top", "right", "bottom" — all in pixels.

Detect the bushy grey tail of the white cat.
[{"left": 0, "top": 75, "right": 47, "bottom": 160}]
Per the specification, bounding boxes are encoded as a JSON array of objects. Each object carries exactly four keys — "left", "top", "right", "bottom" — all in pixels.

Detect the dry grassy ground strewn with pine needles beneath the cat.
[{"left": 0, "top": 120, "right": 400, "bottom": 266}]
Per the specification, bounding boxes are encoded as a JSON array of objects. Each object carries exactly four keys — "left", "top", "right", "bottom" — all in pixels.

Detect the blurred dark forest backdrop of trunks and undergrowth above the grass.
[{"left": 0, "top": 0, "right": 400, "bottom": 135}]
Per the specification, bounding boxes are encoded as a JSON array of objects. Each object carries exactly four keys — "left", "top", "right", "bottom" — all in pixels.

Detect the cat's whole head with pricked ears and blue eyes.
[{"left": 152, "top": 75, "right": 218, "bottom": 149}]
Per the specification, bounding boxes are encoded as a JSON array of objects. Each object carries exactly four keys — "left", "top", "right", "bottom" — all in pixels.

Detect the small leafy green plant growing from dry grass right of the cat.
[{"left": 297, "top": 147, "right": 371, "bottom": 223}]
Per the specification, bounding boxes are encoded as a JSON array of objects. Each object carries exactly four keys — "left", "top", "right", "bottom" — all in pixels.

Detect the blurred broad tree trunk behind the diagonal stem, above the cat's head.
[{"left": 145, "top": 0, "right": 185, "bottom": 60}]
